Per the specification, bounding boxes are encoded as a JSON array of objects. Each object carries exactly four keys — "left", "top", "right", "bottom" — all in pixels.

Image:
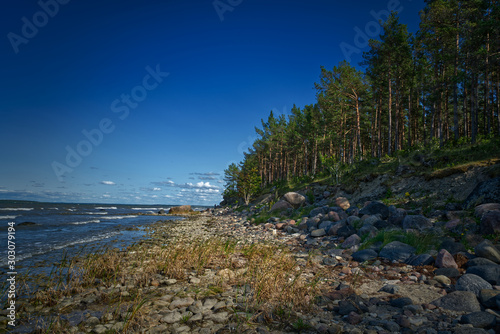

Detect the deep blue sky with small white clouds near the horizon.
[{"left": 0, "top": 0, "right": 424, "bottom": 205}]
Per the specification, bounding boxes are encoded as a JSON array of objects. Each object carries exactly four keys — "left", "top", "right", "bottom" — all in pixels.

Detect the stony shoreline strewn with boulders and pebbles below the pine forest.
[{"left": 2, "top": 177, "right": 500, "bottom": 334}]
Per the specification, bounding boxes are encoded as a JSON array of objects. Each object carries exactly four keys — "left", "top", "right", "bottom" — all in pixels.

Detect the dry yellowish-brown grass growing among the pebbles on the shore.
[{"left": 19, "top": 238, "right": 319, "bottom": 333}]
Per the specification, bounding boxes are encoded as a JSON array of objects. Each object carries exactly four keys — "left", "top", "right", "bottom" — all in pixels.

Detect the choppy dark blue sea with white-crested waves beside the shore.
[{"left": 0, "top": 201, "right": 205, "bottom": 276}]
